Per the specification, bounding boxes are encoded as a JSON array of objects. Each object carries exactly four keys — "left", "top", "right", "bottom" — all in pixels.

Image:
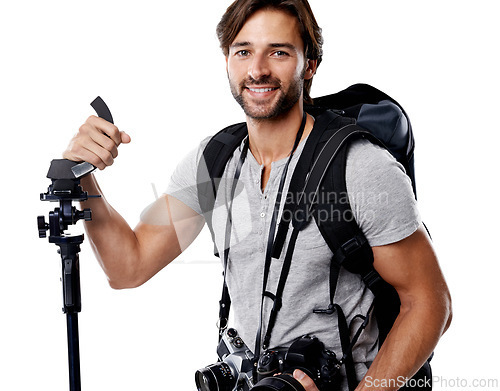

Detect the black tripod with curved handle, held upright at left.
[{"left": 38, "top": 97, "right": 113, "bottom": 391}]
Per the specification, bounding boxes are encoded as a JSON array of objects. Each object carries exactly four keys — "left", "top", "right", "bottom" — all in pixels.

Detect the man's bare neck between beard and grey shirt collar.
[{"left": 247, "top": 104, "right": 314, "bottom": 167}]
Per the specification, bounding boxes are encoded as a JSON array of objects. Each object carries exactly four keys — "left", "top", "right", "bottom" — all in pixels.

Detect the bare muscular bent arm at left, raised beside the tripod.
[{"left": 82, "top": 176, "right": 204, "bottom": 289}]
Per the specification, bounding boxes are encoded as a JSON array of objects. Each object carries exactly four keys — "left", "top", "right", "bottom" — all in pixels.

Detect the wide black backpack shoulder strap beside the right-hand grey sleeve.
[{"left": 306, "top": 125, "right": 400, "bottom": 345}]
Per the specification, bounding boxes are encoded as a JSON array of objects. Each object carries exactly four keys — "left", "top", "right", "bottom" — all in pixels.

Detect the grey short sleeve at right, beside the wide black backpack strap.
[{"left": 346, "top": 140, "right": 421, "bottom": 247}]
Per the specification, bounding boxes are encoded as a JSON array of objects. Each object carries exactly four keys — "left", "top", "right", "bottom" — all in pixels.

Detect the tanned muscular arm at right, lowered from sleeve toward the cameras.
[{"left": 356, "top": 227, "right": 451, "bottom": 391}]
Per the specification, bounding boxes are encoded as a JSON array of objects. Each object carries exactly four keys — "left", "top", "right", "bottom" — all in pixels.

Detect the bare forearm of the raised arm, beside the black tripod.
[{"left": 82, "top": 175, "right": 140, "bottom": 288}]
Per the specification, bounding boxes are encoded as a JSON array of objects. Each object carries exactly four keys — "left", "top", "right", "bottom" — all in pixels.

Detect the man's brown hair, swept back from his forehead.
[{"left": 217, "top": 0, "right": 323, "bottom": 104}]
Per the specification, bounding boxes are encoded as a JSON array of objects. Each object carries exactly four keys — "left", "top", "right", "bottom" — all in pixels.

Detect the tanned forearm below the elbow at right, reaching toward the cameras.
[{"left": 356, "top": 303, "right": 451, "bottom": 391}]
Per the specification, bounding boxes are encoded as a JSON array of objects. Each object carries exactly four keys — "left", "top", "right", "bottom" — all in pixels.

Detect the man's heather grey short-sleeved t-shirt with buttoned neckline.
[{"left": 166, "top": 131, "right": 420, "bottom": 379}]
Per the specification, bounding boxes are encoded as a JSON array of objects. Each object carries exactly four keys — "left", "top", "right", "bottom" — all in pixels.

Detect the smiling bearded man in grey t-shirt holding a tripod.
[{"left": 64, "top": 0, "right": 451, "bottom": 391}]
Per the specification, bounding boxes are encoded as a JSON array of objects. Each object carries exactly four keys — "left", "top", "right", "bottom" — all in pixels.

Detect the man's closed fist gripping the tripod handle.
[{"left": 63, "top": 115, "right": 130, "bottom": 170}]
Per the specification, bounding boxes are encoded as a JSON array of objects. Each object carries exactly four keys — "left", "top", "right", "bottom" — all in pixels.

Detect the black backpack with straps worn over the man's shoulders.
[{"left": 198, "top": 84, "right": 431, "bottom": 390}]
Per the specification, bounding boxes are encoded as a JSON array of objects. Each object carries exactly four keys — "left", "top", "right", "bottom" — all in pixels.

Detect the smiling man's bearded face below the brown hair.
[{"left": 226, "top": 10, "right": 313, "bottom": 119}]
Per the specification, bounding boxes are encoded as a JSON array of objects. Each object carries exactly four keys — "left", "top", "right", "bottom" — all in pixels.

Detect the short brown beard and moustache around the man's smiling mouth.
[{"left": 228, "top": 68, "right": 306, "bottom": 120}]
